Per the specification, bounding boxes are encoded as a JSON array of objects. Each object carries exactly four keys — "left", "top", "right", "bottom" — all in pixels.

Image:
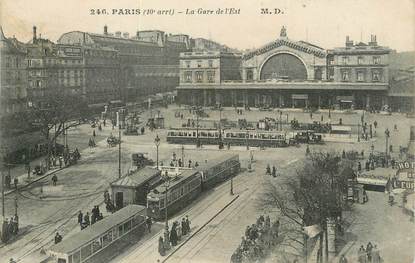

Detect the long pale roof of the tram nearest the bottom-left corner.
[{"left": 49, "top": 205, "right": 146, "bottom": 254}]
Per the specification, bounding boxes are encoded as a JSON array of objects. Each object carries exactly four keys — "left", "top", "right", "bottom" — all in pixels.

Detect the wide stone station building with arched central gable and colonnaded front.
[{"left": 177, "top": 27, "right": 390, "bottom": 109}]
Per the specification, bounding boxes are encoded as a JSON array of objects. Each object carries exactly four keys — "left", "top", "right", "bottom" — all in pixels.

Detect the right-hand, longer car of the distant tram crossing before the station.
[{"left": 223, "top": 130, "right": 288, "bottom": 148}]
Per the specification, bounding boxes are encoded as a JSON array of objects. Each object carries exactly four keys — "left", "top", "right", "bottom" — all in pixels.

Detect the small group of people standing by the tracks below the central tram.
[{"left": 158, "top": 216, "right": 191, "bottom": 256}]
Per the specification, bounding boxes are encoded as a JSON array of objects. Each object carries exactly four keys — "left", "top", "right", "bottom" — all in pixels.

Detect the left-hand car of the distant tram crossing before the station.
[{"left": 167, "top": 128, "right": 221, "bottom": 144}]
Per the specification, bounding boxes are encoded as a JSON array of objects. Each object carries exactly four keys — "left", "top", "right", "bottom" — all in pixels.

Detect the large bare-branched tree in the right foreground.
[{"left": 259, "top": 152, "right": 350, "bottom": 256}]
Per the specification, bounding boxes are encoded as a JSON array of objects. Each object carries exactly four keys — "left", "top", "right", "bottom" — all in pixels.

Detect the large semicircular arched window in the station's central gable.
[{"left": 261, "top": 53, "right": 307, "bottom": 80}]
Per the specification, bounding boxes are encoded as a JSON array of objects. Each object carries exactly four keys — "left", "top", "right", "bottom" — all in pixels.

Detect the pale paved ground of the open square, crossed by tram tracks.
[{"left": 0, "top": 107, "right": 413, "bottom": 262}]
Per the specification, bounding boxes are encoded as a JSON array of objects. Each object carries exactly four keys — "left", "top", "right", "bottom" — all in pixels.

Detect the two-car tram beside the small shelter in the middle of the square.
[{"left": 147, "top": 154, "right": 240, "bottom": 220}]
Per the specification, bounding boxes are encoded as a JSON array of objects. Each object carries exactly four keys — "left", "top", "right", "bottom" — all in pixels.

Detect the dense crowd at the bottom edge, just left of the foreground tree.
[{"left": 231, "top": 215, "right": 280, "bottom": 263}]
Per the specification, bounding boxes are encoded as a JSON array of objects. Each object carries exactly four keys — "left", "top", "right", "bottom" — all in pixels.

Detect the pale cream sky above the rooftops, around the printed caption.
[{"left": 0, "top": 0, "right": 415, "bottom": 51}]
